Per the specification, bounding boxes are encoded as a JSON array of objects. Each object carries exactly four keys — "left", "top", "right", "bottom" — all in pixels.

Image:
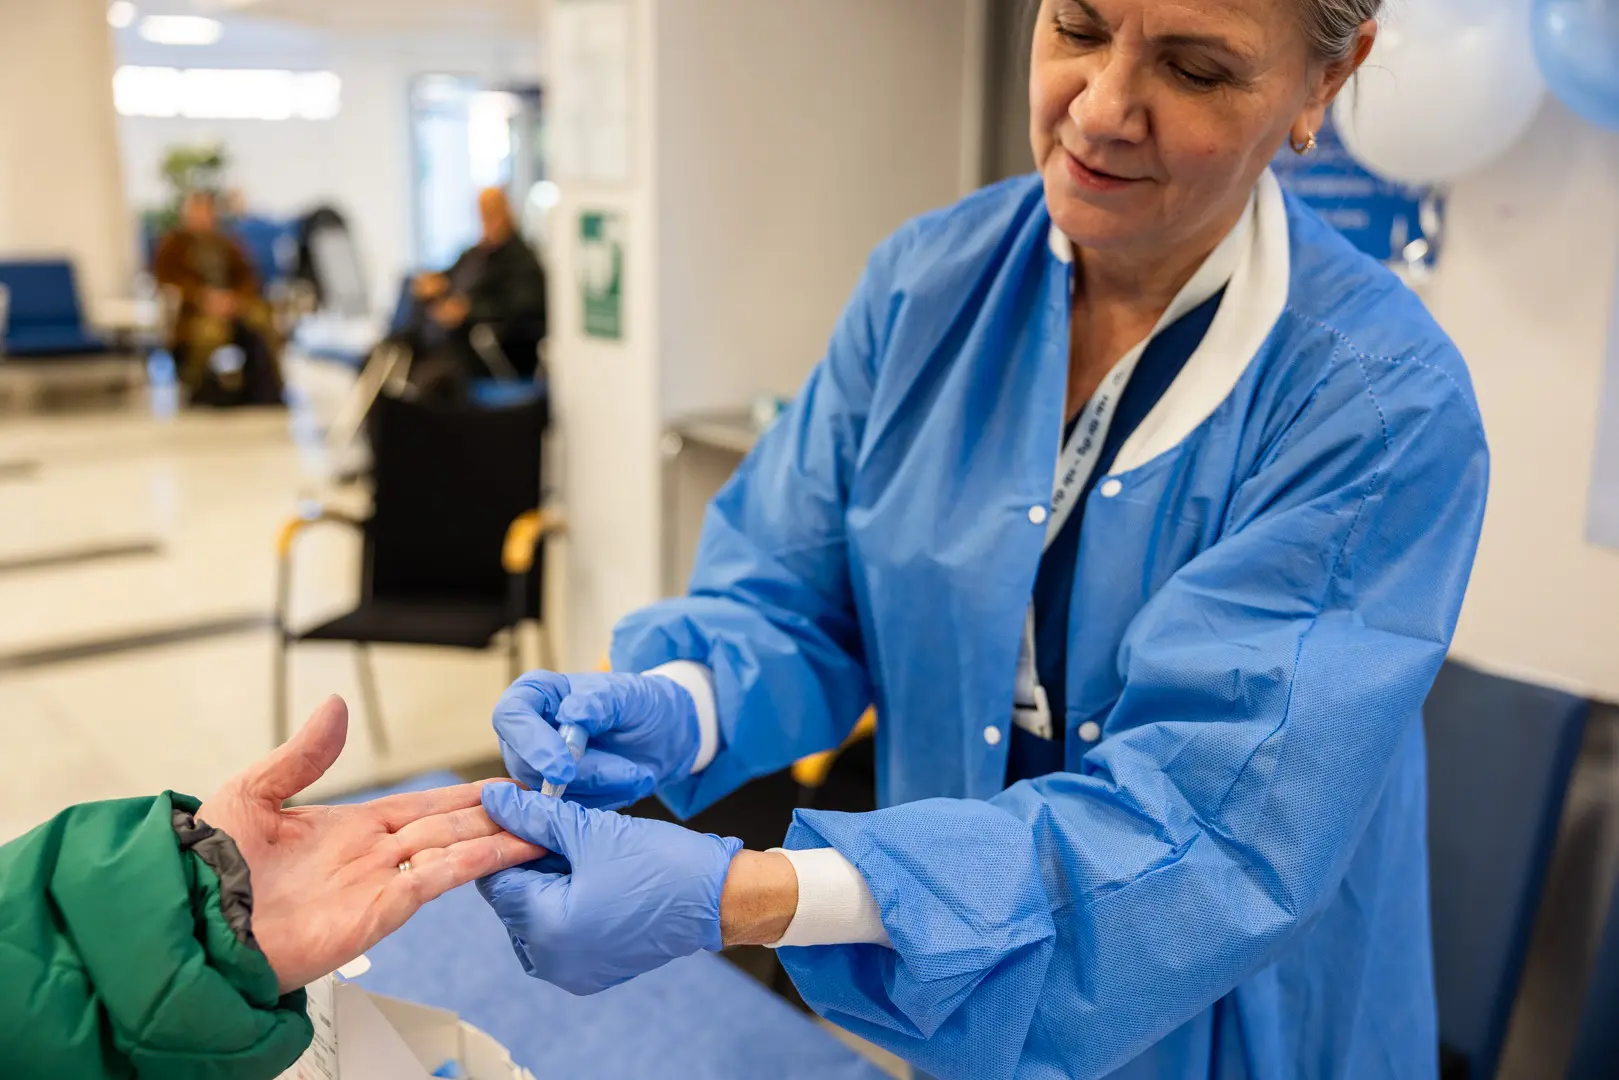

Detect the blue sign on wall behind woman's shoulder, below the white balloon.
[{"left": 1271, "top": 117, "right": 1444, "bottom": 269}]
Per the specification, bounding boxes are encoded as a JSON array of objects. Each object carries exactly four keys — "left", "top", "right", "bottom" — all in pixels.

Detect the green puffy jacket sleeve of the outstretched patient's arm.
[{"left": 0, "top": 792, "right": 312, "bottom": 1080}]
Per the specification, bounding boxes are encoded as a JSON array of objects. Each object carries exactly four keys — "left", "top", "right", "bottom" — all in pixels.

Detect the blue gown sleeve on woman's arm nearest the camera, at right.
[{"left": 780, "top": 347, "right": 1488, "bottom": 1077}]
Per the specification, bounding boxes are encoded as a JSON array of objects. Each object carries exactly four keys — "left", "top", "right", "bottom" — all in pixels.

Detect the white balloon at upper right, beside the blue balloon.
[{"left": 1332, "top": 0, "right": 1546, "bottom": 185}]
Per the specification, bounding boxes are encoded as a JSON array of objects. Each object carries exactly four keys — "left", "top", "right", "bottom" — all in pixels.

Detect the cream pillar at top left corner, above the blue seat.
[{"left": 0, "top": 0, "right": 134, "bottom": 303}]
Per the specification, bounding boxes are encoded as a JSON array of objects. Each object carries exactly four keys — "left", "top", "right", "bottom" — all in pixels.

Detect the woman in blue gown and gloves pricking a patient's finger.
[{"left": 481, "top": 0, "right": 1488, "bottom": 1080}]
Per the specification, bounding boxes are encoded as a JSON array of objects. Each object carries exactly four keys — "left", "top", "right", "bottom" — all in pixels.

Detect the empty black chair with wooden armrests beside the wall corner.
[{"left": 275, "top": 395, "right": 562, "bottom": 748}]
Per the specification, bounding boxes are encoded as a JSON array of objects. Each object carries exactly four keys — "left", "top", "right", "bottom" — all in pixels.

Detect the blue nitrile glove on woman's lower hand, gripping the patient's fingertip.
[{"left": 478, "top": 784, "right": 742, "bottom": 996}]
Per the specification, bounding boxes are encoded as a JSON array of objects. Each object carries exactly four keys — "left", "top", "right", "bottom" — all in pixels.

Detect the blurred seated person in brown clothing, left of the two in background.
[{"left": 152, "top": 191, "right": 282, "bottom": 405}]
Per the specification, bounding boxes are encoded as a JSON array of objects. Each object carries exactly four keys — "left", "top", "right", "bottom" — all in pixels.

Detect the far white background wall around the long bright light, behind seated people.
[{"left": 118, "top": 19, "right": 541, "bottom": 309}]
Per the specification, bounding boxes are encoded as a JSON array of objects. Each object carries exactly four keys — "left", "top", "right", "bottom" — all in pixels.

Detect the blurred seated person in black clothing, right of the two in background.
[{"left": 389, "top": 188, "right": 546, "bottom": 400}]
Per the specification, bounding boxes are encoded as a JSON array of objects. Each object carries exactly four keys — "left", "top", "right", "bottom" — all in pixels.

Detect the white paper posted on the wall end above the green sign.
[{"left": 550, "top": 0, "right": 635, "bottom": 185}]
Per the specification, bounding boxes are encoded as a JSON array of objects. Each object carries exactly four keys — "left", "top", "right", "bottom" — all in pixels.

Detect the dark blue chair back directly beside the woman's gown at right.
[{"left": 1423, "top": 664, "right": 1590, "bottom": 1080}]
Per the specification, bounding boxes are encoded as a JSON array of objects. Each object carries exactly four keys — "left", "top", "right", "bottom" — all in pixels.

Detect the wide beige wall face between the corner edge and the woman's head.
[{"left": 657, "top": 0, "right": 981, "bottom": 415}]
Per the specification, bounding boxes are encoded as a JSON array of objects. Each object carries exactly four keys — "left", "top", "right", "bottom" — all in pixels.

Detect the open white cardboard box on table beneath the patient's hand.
[{"left": 280, "top": 960, "right": 534, "bottom": 1080}]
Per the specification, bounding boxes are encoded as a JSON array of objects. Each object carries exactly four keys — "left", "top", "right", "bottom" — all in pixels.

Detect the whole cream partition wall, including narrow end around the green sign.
[{"left": 552, "top": 0, "right": 981, "bottom": 667}]
